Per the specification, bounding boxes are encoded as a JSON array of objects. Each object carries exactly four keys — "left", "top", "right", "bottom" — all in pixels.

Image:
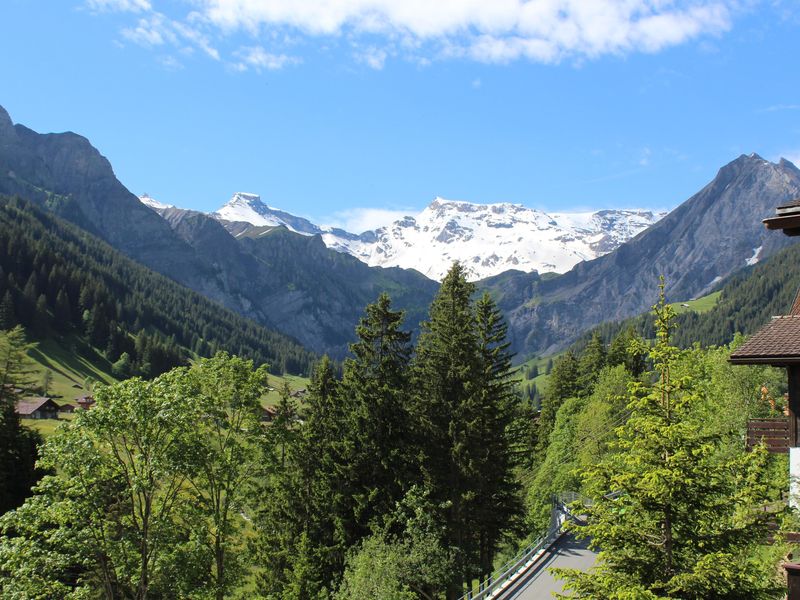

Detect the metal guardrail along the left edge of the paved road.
[{"left": 459, "top": 492, "right": 590, "bottom": 600}]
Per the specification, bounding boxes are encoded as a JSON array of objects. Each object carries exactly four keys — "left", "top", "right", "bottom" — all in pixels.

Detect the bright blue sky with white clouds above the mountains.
[{"left": 0, "top": 0, "right": 800, "bottom": 229}]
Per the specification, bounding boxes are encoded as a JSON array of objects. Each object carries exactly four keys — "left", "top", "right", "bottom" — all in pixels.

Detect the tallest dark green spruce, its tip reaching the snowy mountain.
[{"left": 412, "top": 263, "right": 520, "bottom": 598}]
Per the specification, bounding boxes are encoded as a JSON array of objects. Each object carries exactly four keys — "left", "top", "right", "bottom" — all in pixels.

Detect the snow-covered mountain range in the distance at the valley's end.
[{"left": 142, "top": 192, "right": 665, "bottom": 280}]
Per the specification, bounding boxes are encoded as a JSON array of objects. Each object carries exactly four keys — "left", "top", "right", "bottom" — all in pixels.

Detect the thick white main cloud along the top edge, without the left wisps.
[{"left": 197, "top": 0, "right": 734, "bottom": 63}]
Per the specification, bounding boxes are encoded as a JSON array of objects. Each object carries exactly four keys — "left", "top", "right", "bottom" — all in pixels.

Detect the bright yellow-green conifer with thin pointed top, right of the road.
[{"left": 562, "top": 280, "right": 777, "bottom": 600}]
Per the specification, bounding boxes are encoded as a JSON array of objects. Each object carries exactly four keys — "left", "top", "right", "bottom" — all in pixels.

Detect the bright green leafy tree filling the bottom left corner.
[{"left": 0, "top": 376, "right": 202, "bottom": 600}]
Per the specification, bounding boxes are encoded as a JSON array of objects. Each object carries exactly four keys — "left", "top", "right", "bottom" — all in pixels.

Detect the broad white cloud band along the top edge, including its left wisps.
[{"left": 85, "top": 0, "right": 739, "bottom": 69}]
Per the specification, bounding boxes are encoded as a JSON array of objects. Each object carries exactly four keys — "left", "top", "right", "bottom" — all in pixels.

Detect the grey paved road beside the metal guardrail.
[{"left": 497, "top": 534, "right": 597, "bottom": 600}]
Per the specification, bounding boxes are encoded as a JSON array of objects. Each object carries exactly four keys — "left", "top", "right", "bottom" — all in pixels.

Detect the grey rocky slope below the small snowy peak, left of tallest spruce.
[{"left": 145, "top": 202, "right": 438, "bottom": 358}]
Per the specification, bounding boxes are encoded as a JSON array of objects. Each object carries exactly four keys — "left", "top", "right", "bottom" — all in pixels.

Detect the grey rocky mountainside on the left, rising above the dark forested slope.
[{"left": 0, "top": 104, "right": 435, "bottom": 358}]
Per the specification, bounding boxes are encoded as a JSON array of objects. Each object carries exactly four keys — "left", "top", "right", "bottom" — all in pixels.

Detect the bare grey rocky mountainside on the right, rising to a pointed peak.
[{"left": 482, "top": 154, "right": 800, "bottom": 353}]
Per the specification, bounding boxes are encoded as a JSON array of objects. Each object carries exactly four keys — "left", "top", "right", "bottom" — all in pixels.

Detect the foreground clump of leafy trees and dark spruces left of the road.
[{"left": 0, "top": 264, "right": 530, "bottom": 600}]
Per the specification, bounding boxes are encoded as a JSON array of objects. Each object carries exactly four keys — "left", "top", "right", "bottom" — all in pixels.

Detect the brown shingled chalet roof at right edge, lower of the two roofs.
[{"left": 730, "top": 315, "right": 800, "bottom": 366}]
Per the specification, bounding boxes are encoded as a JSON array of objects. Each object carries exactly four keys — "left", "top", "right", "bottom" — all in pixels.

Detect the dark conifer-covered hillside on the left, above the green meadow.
[{"left": 0, "top": 197, "right": 314, "bottom": 377}]
